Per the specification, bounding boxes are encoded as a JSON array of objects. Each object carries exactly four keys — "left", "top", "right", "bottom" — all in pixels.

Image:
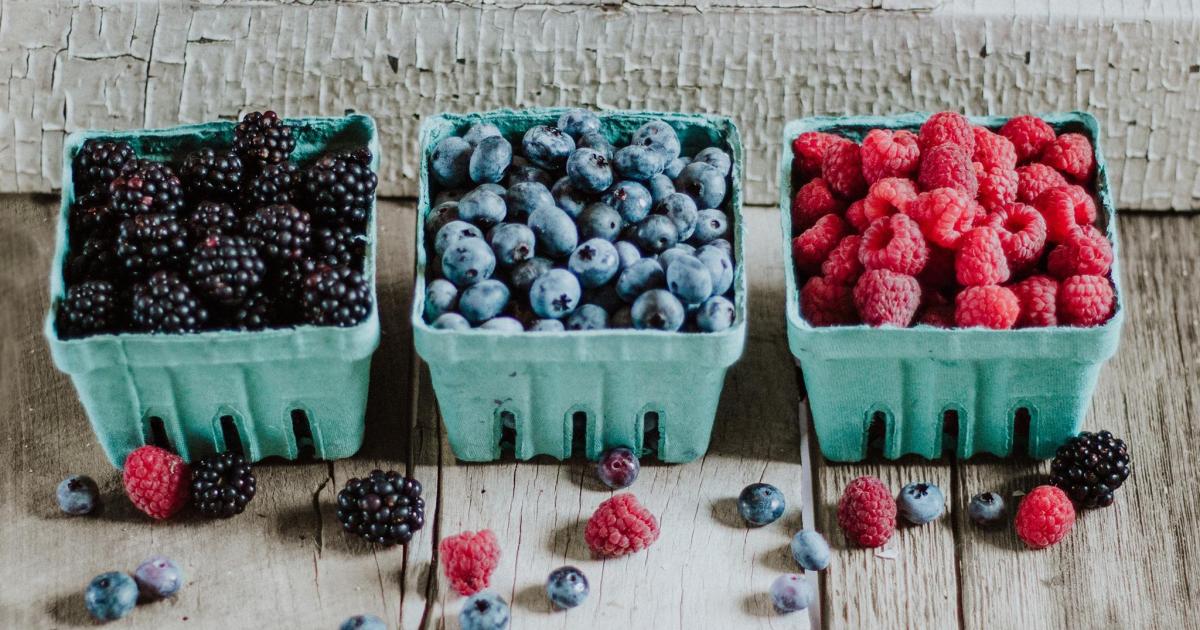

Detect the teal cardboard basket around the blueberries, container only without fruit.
[{"left": 412, "top": 109, "right": 746, "bottom": 462}]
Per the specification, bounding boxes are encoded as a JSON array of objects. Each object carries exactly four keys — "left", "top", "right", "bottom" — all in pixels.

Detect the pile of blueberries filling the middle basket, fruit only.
[{"left": 425, "top": 109, "right": 736, "bottom": 332}]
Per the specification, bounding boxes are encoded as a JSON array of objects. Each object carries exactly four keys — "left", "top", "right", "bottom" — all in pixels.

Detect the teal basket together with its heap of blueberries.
[{"left": 412, "top": 109, "right": 745, "bottom": 462}]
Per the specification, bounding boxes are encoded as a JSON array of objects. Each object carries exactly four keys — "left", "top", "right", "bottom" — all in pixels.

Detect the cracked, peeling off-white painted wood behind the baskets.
[{"left": 0, "top": 0, "right": 1200, "bottom": 210}]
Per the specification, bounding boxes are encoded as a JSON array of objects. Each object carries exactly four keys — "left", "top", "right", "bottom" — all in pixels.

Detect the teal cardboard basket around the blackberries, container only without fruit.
[{"left": 44, "top": 114, "right": 379, "bottom": 467}]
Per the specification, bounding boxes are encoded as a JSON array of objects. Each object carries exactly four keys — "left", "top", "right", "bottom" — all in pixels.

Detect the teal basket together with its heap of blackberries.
[{"left": 46, "top": 112, "right": 379, "bottom": 466}]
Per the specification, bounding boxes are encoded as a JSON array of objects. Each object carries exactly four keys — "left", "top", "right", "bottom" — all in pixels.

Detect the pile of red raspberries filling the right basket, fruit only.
[{"left": 792, "top": 112, "right": 1116, "bottom": 329}]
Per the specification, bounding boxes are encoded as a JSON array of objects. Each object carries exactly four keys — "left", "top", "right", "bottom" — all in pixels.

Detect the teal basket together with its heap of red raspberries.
[{"left": 780, "top": 112, "right": 1123, "bottom": 461}]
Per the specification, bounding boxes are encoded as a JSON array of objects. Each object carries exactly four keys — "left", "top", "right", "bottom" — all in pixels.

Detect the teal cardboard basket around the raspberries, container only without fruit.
[{"left": 779, "top": 112, "right": 1124, "bottom": 462}]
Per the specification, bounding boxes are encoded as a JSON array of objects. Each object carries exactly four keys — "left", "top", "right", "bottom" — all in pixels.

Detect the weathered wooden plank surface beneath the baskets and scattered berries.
[{"left": 0, "top": 196, "right": 1200, "bottom": 629}]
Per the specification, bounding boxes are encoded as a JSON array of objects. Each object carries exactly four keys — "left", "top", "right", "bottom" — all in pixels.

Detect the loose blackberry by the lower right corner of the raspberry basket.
[{"left": 1050, "top": 431, "right": 1129, "bottom": 509}]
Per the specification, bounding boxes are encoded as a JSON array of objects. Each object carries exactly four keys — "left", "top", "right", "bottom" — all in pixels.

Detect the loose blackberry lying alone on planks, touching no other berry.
[{"left": 337, "top": 470, "right": 425, "bottom": 546}]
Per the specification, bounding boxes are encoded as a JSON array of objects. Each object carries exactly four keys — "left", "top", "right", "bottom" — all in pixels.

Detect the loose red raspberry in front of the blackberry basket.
[{"left": 121, "top": 446, "right": 192, "bottom": 521}]
